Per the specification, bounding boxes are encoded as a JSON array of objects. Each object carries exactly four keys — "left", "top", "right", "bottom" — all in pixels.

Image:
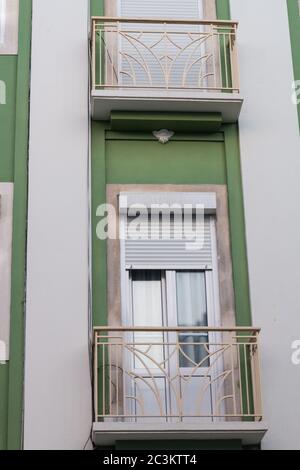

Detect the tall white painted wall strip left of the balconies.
[{"left": 24, "top": 0, "right": 92, "bottom": 449}]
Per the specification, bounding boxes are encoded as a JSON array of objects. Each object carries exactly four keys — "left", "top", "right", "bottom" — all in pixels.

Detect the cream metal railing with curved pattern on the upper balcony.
[{"left": 91, "top": 17, "right": 239, "bottom": 93}]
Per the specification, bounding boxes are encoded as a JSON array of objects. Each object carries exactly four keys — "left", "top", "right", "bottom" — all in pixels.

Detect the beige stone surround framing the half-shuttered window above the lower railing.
[{"left": 106, "top": 184, "right": 235, "bottom": 327}]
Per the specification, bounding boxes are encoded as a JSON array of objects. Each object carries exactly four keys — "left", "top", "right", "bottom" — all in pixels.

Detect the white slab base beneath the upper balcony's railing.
[{"left": 91, "top": 89, "right": 243, "bottom": 123}]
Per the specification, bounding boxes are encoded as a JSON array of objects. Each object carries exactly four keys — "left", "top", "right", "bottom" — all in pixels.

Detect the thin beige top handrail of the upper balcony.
[{"left": 92, "top": 16, "right": 239, "bottom": 28}]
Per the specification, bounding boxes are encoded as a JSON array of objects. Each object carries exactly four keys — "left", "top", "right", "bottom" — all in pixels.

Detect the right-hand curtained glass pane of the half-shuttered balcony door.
[{"left": 176, "top": 272, "right": 209, "bottom": 367}]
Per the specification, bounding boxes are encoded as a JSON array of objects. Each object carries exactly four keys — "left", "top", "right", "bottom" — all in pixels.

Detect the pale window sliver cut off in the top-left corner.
[{"left": 0, "top": 0, "right": 19, "bottom": 55}]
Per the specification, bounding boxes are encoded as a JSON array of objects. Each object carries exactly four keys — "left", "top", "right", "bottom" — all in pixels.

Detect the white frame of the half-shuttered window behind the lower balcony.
[{"left": 119, "top": 192, "right": 222, "bottom": 421}]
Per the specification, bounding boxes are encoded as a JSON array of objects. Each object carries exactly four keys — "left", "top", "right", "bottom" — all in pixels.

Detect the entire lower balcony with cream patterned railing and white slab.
[{"left": 93, "top": 327, "right": 266, "bottom": 446}]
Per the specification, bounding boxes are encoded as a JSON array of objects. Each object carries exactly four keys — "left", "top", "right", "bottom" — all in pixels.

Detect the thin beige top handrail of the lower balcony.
[{"left": 93, "top": 325, "right": 261, "bottom": 334}]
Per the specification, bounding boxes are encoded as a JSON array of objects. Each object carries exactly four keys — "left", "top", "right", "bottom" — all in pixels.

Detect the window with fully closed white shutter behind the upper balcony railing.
[{"left": 96, "top": 0, "right": 221, "bottom": 91}]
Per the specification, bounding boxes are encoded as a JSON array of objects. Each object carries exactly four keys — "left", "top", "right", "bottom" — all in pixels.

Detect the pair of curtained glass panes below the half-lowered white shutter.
[{"left": 127, "top": 270, "right": 215, "bottom": 368}]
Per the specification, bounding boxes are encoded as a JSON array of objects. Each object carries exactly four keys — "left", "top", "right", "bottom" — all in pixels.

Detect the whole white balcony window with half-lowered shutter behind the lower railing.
[{"left": 119, "top": 193, "right": 220, "bottom": 421}]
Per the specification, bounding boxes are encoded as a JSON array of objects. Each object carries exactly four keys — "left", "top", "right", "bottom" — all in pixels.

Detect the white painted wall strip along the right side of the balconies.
[{"left": 231, "top": 0, "right": 300, "bottom": 449}]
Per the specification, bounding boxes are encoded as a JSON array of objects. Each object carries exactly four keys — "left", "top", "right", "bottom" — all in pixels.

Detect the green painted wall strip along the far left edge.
[{"left": 0, "top": 0, "right": 31, "bottom": 450}]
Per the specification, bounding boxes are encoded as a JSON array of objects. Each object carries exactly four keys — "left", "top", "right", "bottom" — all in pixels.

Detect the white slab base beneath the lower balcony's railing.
[{"left": 93, "top": 421, "right": 267, "bottom": 446}]
